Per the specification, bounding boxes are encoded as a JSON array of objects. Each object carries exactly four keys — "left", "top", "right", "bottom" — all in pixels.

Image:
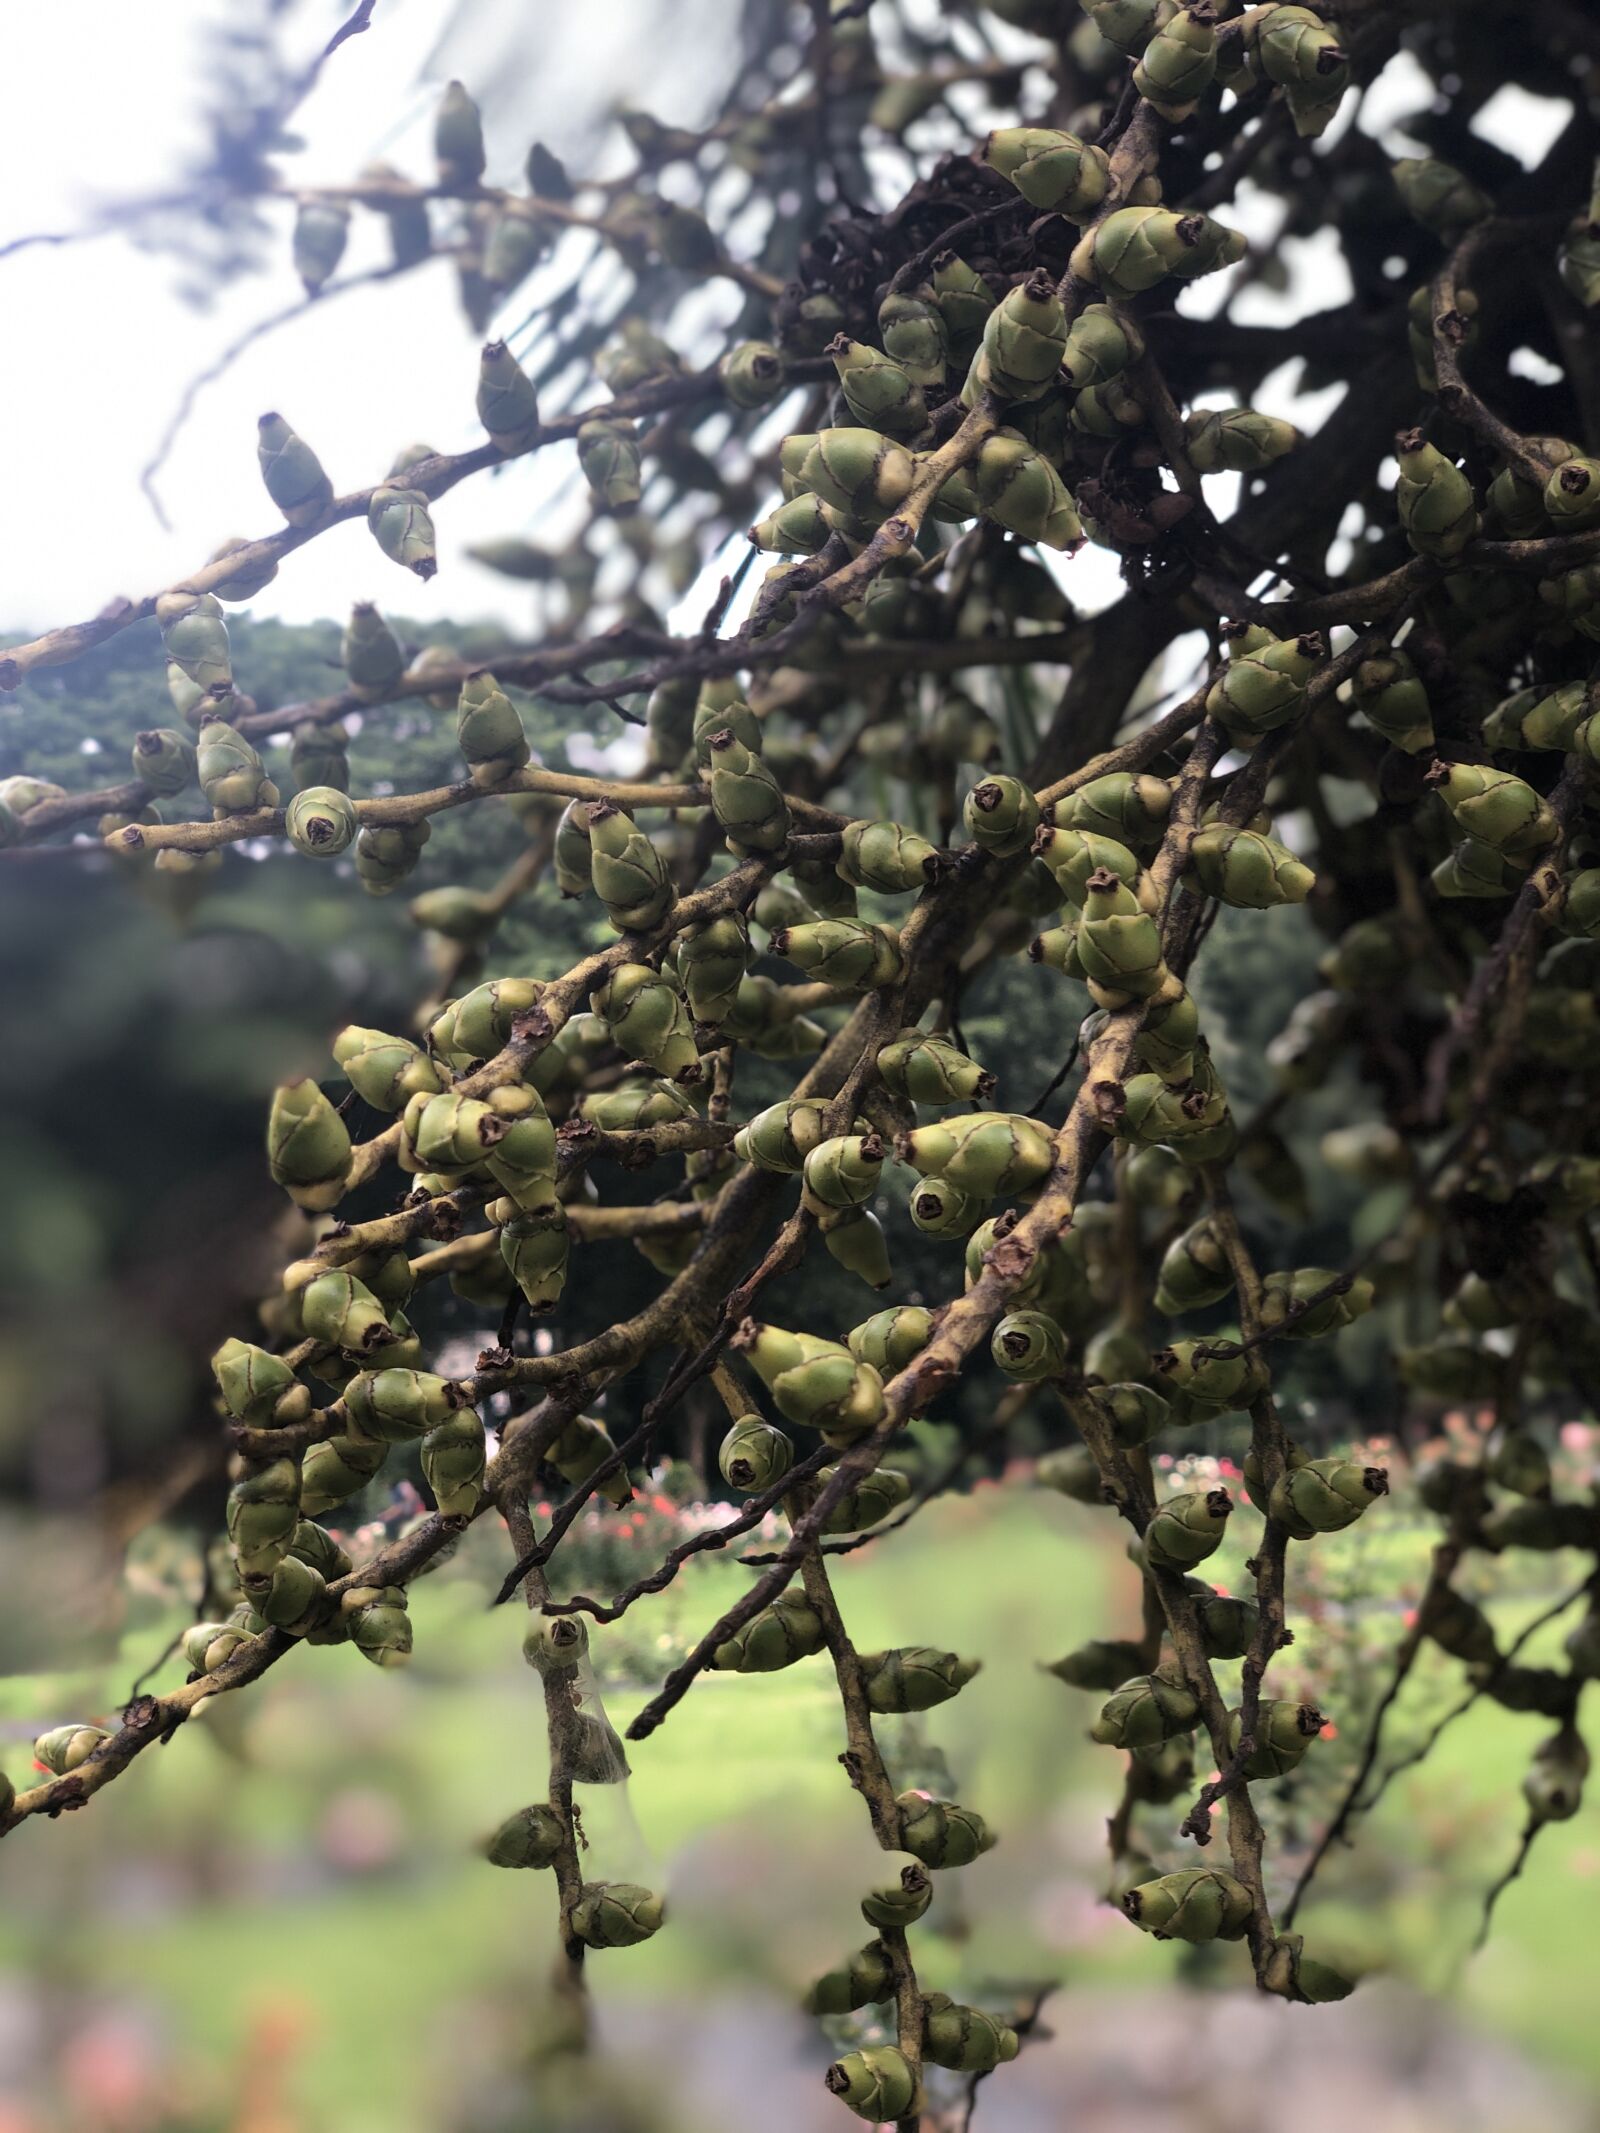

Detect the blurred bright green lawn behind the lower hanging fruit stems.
[{"left": 0, "top": 1489, "right": 1600, "bottom": 2133}]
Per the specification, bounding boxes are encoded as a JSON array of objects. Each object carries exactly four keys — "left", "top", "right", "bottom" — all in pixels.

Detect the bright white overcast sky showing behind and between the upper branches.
[{"left": 0, "top": 0, "right": 1566, "bottom": 631}]
